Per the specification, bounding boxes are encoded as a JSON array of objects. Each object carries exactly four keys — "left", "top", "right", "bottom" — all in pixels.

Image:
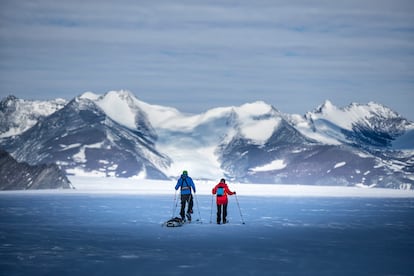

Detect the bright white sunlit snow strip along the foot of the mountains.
[{"left": 62, "top": 176, "right": 414, "bottom": 197}]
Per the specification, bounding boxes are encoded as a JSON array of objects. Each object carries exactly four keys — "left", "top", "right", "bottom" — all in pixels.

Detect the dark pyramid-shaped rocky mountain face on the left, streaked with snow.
[{"left": 4, "top": 97, "right": 170, "bottom": 179}]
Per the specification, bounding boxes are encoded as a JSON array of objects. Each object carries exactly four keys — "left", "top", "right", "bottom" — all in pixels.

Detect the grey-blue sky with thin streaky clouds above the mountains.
[{"left": 0, "top": 0, "right": 414, "bottom": 120}]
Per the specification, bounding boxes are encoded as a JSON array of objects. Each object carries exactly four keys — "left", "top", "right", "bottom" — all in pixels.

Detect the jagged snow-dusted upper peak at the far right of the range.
[{"left": 290, "top": 101, "right": 414, "bottom": 150}]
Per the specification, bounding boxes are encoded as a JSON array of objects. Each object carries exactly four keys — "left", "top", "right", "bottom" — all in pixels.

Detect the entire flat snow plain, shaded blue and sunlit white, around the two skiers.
[{"left": 0, "top": 177, "right": 414, "bottom": 276}]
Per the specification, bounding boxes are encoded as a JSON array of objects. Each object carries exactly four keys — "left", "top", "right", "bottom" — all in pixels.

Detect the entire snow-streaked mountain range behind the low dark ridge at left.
[{"left": 0, "top": 91, "right": 414, "bottom": 189}]
